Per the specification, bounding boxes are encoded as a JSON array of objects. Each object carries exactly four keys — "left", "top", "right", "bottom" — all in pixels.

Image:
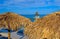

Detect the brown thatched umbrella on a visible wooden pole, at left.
[{"left": 0, "top": 12, "right": 30, "bottom": 39}]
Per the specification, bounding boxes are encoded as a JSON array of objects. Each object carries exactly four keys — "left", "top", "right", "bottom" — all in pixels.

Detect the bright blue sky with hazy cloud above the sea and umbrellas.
[{"left": 0, "top": 0, "right": 60, "bottom": 14}]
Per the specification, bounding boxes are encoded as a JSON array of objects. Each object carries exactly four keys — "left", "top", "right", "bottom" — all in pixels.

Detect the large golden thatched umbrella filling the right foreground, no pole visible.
[{"left": 24, "top": 13, "right": 60, "bottom": 39}]
